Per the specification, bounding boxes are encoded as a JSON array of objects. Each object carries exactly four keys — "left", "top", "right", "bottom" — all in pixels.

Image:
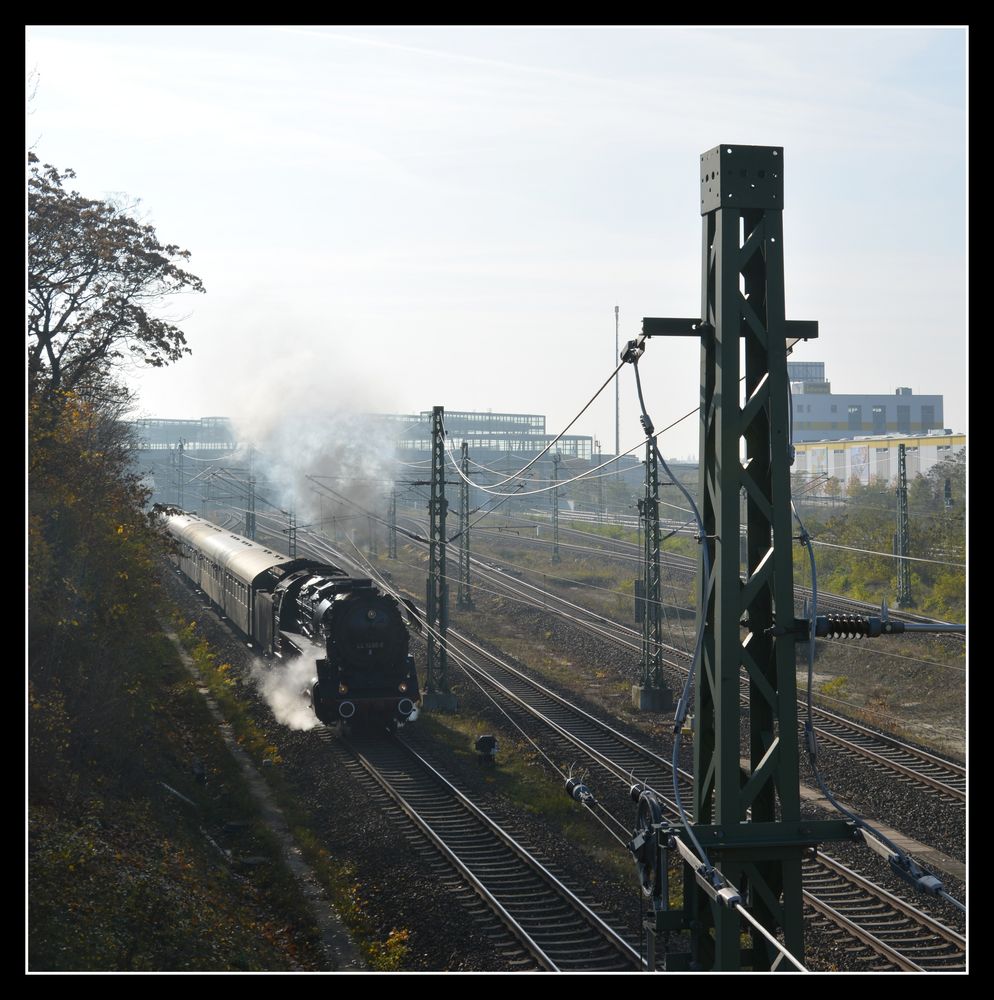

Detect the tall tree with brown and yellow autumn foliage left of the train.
[{"left": 27, "top": 156, "right": 203, "bottom": 807}]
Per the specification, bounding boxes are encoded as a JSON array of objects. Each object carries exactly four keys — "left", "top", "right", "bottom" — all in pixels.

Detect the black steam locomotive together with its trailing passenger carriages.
[{"left": 156, "top": 506, "right": 421, "bottom": 728}]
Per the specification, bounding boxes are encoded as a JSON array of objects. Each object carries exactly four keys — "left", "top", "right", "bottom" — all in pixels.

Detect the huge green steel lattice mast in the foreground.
[{"left": 631, "top": 145, "right": 840, "bottom": 971}]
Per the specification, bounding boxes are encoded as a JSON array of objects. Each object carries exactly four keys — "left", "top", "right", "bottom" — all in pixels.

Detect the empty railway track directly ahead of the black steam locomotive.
[{"left": 322, "top": 730, "right": 642, "bottom": 972}]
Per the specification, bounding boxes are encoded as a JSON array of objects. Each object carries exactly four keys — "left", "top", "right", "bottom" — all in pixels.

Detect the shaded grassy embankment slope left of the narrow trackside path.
[{"left": 28, "top": 635, "right": 325, "bottom": 970}]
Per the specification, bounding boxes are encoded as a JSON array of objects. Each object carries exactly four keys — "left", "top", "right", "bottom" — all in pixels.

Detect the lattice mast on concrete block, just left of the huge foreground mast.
[{"left": 632, "top": 437, "right": 673, "bottom": 712}]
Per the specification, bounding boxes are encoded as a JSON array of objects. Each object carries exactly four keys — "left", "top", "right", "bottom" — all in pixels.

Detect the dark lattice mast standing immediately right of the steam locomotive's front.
[{"left": 422, "top": 406, "right": 456, "bottom": 712}]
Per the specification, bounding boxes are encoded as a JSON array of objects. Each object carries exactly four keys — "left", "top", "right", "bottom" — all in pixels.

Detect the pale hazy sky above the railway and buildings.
[{"left": 27, "top": 27, "right": 967, "bottom": 457}]
